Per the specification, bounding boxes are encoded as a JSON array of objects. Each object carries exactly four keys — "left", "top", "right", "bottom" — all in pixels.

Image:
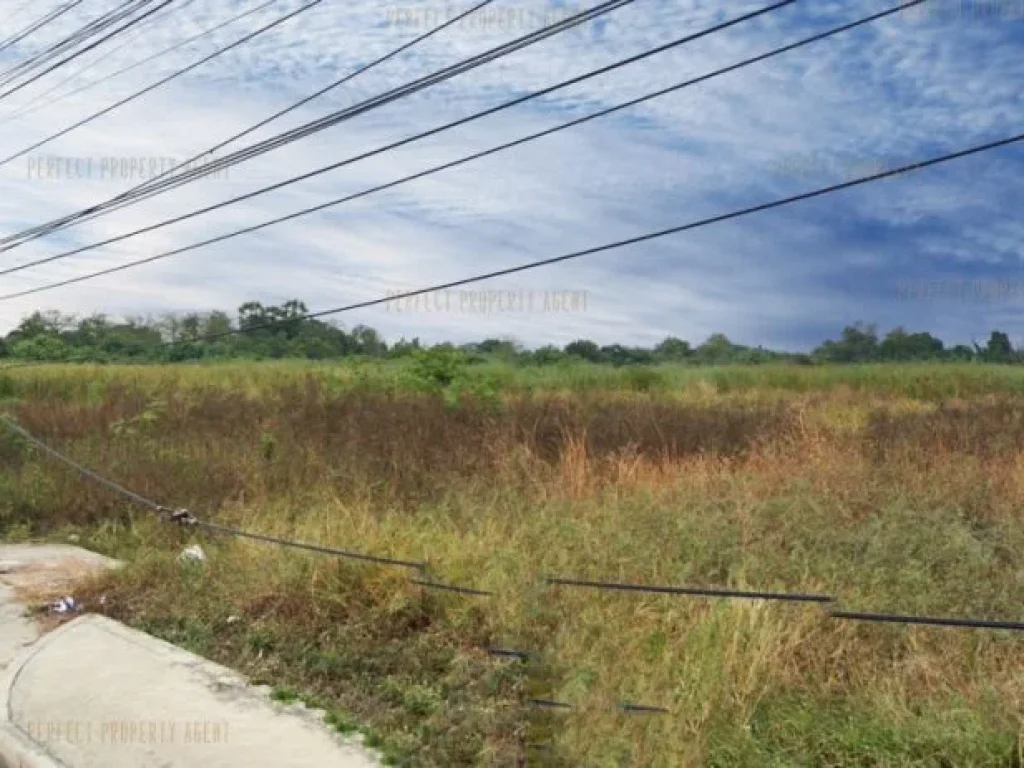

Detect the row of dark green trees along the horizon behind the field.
[{"left": 0, "top": 300, "right": 1024, "bottom": 366}]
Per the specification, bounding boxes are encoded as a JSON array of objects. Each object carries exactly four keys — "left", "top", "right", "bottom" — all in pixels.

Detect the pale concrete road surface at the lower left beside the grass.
[{"left": 0, "top": 546, "right": 382, "bottom": 768}]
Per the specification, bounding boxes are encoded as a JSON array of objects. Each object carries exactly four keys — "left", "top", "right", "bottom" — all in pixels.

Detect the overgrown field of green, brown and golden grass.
[{"left": 0, "top": 364, "right": 1024, "bottom": 768}]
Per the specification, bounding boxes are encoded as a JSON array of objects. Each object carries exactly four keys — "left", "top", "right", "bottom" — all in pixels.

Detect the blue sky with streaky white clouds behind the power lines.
[{"left": 0, "top": 0, "right": 1024, "bottom": 351}]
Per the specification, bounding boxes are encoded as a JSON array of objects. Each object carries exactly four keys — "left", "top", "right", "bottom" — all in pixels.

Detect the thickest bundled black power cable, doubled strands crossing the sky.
[{"left": 0, "top": 0, "right": 635, "bottom": 252}]
